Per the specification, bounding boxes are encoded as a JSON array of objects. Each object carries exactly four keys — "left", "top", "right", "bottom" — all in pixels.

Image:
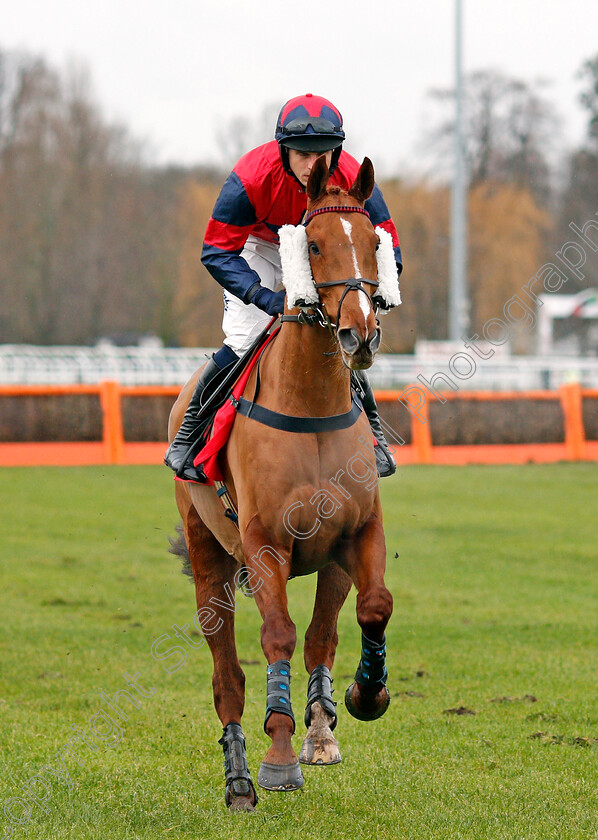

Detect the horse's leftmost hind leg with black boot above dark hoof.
[{"left": 179, "top": 496, "right": 258, "bottom": 811}]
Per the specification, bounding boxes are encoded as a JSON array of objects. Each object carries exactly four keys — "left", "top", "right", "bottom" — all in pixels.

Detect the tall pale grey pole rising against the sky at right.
[{"left": 449, "top": 0, "right": 469, "bottom": 341}]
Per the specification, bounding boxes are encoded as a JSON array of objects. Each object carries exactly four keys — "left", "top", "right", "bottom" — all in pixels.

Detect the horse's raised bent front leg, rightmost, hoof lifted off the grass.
[{"left": 343, "top": 515, "right": 392, "bottom": 720}]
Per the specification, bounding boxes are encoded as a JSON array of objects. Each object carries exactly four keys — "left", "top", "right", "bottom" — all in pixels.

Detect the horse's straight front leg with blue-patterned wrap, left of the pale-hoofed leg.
[{"left": 243, "top": 517, "right": 303, "bottom": 791}]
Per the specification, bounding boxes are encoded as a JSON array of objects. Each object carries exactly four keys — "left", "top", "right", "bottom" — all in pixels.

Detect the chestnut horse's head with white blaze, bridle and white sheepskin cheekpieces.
[{"left": 280, "top": 156, "right": 400, "bottom": 370}]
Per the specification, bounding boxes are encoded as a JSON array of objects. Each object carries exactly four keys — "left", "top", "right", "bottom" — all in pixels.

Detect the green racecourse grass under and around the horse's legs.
[{"left": 0, "top": 464, "right": 598, "bottom": 840}]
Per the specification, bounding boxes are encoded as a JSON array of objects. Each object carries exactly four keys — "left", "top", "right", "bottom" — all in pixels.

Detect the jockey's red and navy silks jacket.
[{"left": 201, "top": 140, "right": 402, "bottom": 303}]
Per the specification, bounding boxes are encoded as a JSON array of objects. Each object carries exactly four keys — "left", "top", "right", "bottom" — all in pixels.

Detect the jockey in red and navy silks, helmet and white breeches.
[{"left": 164, "top": 93, "right": 402, "bottom": 482}]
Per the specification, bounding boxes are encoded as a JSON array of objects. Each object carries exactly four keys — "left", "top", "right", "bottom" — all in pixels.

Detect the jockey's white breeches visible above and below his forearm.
[{"left": 222, "top": 236, "right": 282, "bottom": 356}]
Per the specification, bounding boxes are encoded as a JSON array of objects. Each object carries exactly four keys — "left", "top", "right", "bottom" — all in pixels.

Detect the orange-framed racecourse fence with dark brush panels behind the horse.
[{"left": 0, "top": 380, "right": 598, "bottom": 466}]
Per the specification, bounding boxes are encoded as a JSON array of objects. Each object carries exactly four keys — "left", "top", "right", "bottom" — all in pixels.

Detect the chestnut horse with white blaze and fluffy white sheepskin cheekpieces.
[{"left": 169, "top": 157, "right": 400, "bottom": 810}]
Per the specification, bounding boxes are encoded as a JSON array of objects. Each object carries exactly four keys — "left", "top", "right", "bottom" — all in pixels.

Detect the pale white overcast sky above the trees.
[{"left": 0, "top": 0, "right": 598, "bottom": 174}]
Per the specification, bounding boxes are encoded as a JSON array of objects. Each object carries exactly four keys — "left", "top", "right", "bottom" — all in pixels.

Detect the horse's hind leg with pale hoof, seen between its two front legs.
[{"left": 299, "top": 563, "right": 351, "bottom": 765}]
